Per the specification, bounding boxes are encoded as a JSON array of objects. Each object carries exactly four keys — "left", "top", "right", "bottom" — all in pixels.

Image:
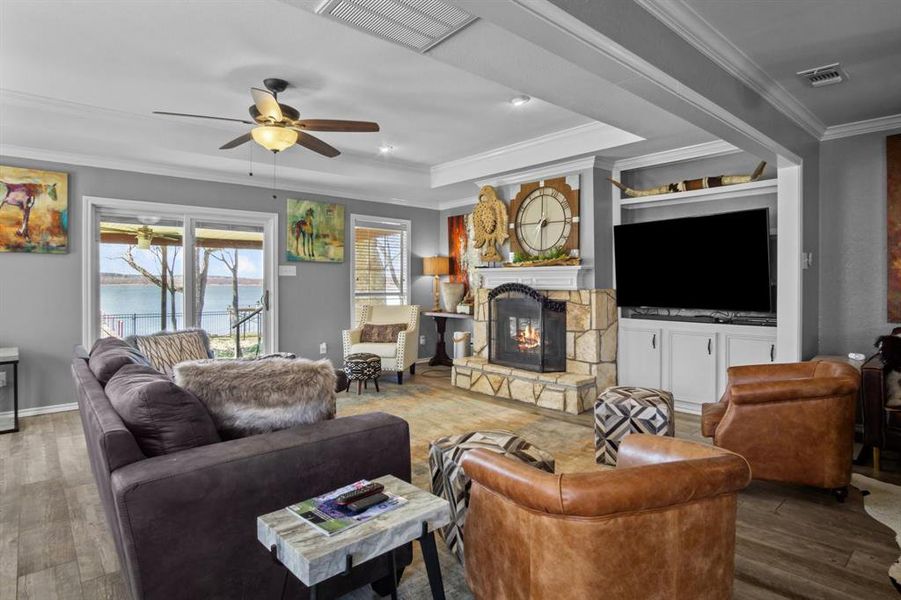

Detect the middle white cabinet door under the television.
[{"left": 666, "top": 330, "right": 716, "bottom": 405}]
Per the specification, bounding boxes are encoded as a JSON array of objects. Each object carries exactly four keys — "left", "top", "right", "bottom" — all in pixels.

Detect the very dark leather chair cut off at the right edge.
[{"left": 861, "top": 327, "right": 901, "bottom": 472}]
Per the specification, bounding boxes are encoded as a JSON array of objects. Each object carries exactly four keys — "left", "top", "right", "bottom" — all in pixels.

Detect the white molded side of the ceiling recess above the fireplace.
[{"left": 431, "top": 121, "right": 644, "bottom": 188}]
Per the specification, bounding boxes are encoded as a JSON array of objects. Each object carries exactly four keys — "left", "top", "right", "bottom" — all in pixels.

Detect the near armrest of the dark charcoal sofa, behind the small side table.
[{"left": 111, "top": 413, "right": 410, "bottom": 598}]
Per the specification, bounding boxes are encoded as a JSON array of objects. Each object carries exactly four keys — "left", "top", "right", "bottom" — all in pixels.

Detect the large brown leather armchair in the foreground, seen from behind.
[{"left": 462, "top": 434, "right": 751, "bottom": 600}]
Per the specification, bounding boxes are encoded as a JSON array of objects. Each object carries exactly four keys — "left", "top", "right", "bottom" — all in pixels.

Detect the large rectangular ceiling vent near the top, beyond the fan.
[{"left": 316, "top": 0, "right": 476, "bottom": 52}]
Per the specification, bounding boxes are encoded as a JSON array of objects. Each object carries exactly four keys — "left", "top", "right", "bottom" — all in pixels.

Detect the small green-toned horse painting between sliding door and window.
[{"left": 285, "top": 198, "right": 344, "bottom": 262}]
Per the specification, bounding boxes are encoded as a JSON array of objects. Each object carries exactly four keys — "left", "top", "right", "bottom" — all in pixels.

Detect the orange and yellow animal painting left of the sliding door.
[{"left": 0, "top": 165, "right": 69, "bottom": 254}]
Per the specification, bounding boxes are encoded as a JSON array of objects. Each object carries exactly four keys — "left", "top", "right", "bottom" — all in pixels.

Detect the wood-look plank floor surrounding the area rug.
[{"left": 0, "top": 370, "right": 901, "bottom": 600}]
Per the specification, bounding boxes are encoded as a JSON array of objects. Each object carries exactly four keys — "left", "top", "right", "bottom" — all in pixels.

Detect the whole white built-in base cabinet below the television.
[{"left": 617, "top": 318, "right": 776, "bottom": 413}]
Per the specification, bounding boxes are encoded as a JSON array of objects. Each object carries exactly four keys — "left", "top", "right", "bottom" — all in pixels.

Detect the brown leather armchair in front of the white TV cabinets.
[{"left": 701, "top": 361, "right": 860, "bottom": 501}]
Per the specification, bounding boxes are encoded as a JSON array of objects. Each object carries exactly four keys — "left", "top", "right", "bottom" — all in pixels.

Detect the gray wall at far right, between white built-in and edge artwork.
[{"left": 814, "top": 129, "right": 901, "bottom": 354}]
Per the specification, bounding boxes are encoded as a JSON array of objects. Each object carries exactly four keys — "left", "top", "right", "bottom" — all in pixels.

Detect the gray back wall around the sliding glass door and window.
[{"left": 0, "top": 157, "right": 438, "bottom": 408}]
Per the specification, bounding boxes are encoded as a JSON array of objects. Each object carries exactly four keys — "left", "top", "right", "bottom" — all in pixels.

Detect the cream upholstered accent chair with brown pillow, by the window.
[{"left": 343, "top": 305, "right": 420, "bottom": 383}]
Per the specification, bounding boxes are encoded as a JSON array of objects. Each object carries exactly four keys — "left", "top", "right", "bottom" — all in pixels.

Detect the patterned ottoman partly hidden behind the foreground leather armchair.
[{"left": 429, "top": 430, "right": 554, "bottom": 564}]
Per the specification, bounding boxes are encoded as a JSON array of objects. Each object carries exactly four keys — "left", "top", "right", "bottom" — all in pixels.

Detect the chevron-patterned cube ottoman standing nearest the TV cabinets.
[{"left": 594, "top": 386, "right": 676, "bottom": 465}]
